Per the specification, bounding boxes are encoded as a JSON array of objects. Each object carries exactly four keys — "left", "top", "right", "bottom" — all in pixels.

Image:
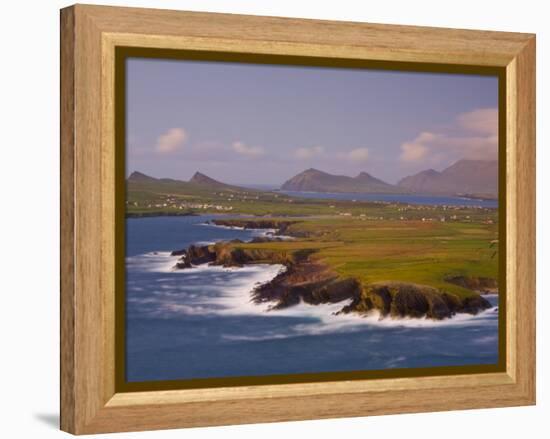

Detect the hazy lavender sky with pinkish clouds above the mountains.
[{"left": 126, "top": 58, "right": 498, "bottom": 185}]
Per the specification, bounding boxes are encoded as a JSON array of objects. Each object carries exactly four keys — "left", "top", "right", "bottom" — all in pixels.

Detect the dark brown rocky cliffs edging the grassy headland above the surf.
[{"left": 172, "top": 219, "right": 498, "bottom": 320}]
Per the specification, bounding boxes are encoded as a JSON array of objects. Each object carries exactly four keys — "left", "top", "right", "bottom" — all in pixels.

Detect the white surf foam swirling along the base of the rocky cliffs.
[{"left": 127, "top": 252, "right": 498, "bottom": 340}]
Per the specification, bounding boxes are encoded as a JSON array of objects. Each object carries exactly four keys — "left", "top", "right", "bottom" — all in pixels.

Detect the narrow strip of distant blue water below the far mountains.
[{"left": 280, "top": 191, "right": 498, "bottom": 208}]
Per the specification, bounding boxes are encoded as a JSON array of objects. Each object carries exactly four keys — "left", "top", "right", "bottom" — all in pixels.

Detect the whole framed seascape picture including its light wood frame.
[{"left": 61, "top": 5, "right": 535, "bottom": 434}]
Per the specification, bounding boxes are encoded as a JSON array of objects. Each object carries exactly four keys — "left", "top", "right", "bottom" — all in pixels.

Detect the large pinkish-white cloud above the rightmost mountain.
[{"left": 400, "top": 108, "right": 498, "bottom": 164}]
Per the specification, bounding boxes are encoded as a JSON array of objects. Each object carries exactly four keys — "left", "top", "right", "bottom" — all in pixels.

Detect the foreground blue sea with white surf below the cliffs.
[{"left": 126, "top": 216, "right": 498, "bottom": 382}]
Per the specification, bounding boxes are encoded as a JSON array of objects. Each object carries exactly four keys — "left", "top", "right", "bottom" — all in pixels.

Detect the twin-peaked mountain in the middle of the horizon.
[{"left": 281, "top": 168, "right": 404, "bottom": 193}]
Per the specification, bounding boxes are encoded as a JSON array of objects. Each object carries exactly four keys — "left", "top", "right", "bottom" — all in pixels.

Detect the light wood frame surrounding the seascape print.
[{"left": 61, "top": 5, "right": 535, "bottom": 434}]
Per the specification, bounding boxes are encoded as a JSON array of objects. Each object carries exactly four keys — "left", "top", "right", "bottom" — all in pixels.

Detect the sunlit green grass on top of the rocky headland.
[{"left": 237, "top": 218, "right": 498, "bottom": 297}]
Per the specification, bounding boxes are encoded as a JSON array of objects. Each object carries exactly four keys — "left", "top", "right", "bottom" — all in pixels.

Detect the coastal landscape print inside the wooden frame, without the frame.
[{"left": 125, "top": 57, "right": 501, "bottom": 382}]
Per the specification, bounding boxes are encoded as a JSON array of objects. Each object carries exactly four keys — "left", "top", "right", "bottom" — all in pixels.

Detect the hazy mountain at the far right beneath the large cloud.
[{"left": 397, "top": 160, "right": 498, "bottom": 197}]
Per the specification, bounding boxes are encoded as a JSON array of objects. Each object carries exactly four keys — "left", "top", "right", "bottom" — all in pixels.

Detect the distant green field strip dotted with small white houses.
[{"left": 126, "top": 180, "right": 496, "bottom": 223}]
